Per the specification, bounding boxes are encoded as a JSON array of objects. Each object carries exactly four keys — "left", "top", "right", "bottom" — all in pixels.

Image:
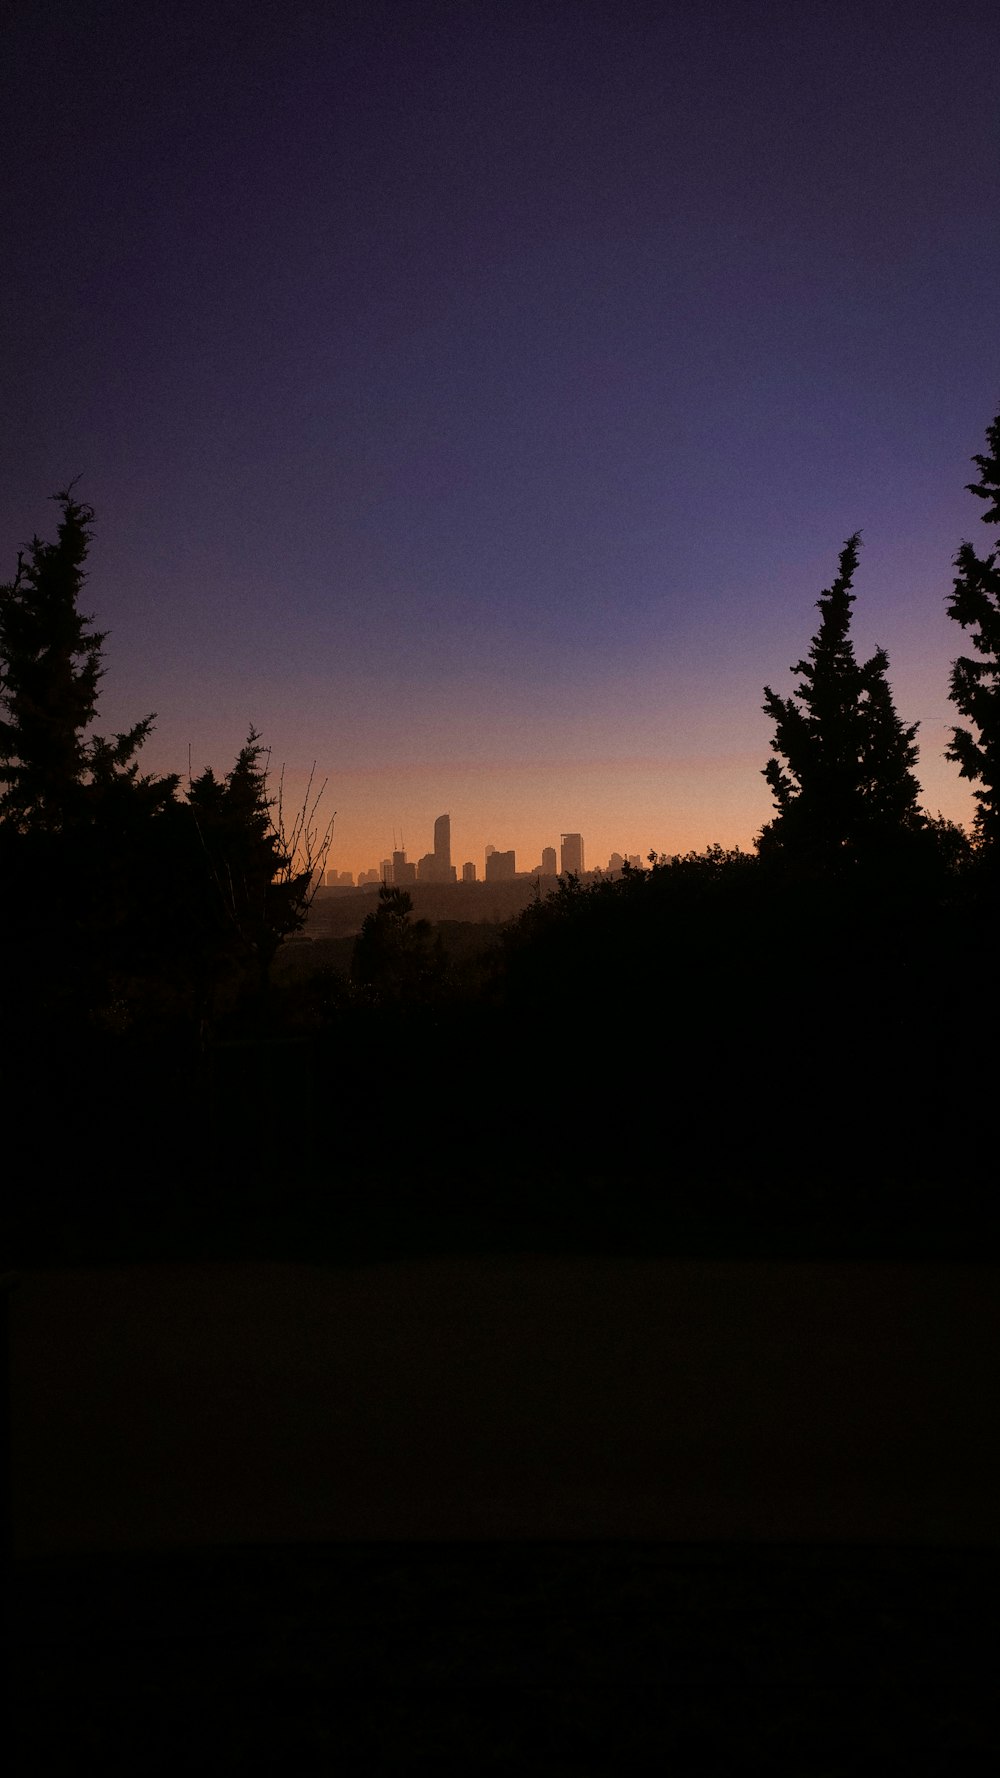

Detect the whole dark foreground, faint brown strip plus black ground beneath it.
[{"left": 7, "top": 1255, "right": 1000, "bottom": 1778}]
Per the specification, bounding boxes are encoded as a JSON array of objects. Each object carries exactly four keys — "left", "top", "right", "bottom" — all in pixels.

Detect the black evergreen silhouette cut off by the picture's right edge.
[{"left": 947, "top": 414, "right": 1000, "bottom": 855}]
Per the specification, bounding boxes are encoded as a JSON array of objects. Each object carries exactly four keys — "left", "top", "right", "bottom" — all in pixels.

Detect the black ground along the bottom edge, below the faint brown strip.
[{"left": 12, "top": 1540, "right": 1000, "bottom": 1778}]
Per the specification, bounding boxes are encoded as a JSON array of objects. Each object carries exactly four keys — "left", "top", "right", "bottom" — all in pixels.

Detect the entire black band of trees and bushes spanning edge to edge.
[{"left": 0, "top": 416, "right": 1000, "bottom": 1251}]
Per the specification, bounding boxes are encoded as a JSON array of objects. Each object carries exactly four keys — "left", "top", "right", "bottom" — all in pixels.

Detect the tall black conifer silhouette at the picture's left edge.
[{"left": 0, "top": 489, "right": 178, "bottom": 1029}]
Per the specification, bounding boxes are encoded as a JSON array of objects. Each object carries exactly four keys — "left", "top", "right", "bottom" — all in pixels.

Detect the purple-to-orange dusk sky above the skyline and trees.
[{"left": 0, "top": 0, "right": 1000, "bottom": 871}]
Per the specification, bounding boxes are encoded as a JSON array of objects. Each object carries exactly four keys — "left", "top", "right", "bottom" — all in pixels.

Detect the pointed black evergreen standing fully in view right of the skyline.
[{"left": 758, "top": 533, "right": 923, "bottom": 869}]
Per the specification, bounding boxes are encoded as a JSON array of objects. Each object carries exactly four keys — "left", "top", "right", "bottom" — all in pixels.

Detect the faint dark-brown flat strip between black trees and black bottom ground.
[{"left": 9, "top": 1255, "right": 1000, "bottom": 1556}]
